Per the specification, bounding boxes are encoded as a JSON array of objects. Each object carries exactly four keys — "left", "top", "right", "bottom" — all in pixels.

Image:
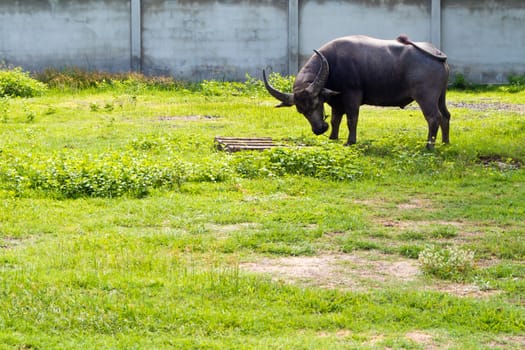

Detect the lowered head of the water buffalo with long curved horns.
[{"left": 263, "top": 50, "right": 339, "bottom": 135}]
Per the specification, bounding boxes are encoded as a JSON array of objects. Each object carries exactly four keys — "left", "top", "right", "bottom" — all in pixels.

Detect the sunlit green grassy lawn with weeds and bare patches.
[{"left": 0, "top": 75, "right": 525, "bottom": 349}]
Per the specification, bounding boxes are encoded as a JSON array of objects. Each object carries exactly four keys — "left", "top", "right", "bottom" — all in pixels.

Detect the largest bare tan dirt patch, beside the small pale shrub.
[{"left": 239, "top": 252, "right": 497, "bottom": 298}]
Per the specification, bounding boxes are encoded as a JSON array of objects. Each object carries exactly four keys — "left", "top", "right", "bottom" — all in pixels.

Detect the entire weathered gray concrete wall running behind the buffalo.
[{"left": 0, "top": 0, "right": 525, "bottom": 83}]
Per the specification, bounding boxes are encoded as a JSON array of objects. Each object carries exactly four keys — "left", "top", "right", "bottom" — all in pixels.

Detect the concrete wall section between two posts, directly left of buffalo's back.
[{"left": 142, "top": 0, "right": 288, "bottom": 80}]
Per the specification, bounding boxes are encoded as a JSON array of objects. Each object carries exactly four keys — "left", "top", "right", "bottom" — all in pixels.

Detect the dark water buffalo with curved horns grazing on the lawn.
[{"left": 263, "top": 35, "right": 450, "bottom": 149}]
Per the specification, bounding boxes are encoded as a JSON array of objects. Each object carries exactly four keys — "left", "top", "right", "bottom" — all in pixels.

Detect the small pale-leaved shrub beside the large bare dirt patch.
[{"left": 419, "top": 246, "right": 474, "bottom": 281}]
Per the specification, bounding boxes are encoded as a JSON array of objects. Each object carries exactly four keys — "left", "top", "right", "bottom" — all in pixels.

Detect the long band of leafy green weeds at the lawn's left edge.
[{"left": 0, "top": 149, "right": 188, "bottom": 198}]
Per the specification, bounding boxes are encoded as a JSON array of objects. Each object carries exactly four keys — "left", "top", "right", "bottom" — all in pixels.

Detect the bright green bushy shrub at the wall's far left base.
[{"left": 0, "top": 67, "right": 47, "bottom": 97}]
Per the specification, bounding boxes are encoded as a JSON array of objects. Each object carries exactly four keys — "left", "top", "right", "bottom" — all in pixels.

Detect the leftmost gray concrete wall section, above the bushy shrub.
[{"left": 0, "top": 0, "right": 130, "bottom": 71}]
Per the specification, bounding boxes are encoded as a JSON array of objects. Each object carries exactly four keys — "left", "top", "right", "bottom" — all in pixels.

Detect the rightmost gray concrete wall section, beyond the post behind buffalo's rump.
[{"left": 442, "top": 0, "right": 525, "bottom": 83}]
